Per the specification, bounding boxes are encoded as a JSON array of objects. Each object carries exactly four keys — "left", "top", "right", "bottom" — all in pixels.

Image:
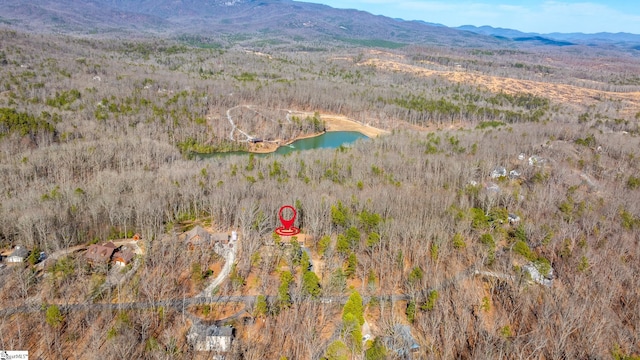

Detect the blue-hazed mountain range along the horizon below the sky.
[{"left": 0, "top": 0, "right": 640, "bottom": 47}]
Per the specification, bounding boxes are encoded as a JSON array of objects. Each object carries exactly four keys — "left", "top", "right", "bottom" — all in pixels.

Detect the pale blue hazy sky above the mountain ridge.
[{"left": 306, "top": 0, "right": 640, "bottom": 34}]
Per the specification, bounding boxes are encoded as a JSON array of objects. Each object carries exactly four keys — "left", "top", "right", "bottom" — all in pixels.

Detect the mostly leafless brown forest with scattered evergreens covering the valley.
[{"left": 0, "top": 26, "right": 640, "bottom": 359}]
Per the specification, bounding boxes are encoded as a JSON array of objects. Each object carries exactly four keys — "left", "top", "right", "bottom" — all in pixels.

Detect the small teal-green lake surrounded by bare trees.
[{"left": 196, "top": 131, "right": 369, "bottom": 158}]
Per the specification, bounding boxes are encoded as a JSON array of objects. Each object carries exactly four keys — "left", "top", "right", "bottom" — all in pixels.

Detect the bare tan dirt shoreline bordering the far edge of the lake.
[{"left": 248, "top": 115, "right": 389, "bottom": 154}]
